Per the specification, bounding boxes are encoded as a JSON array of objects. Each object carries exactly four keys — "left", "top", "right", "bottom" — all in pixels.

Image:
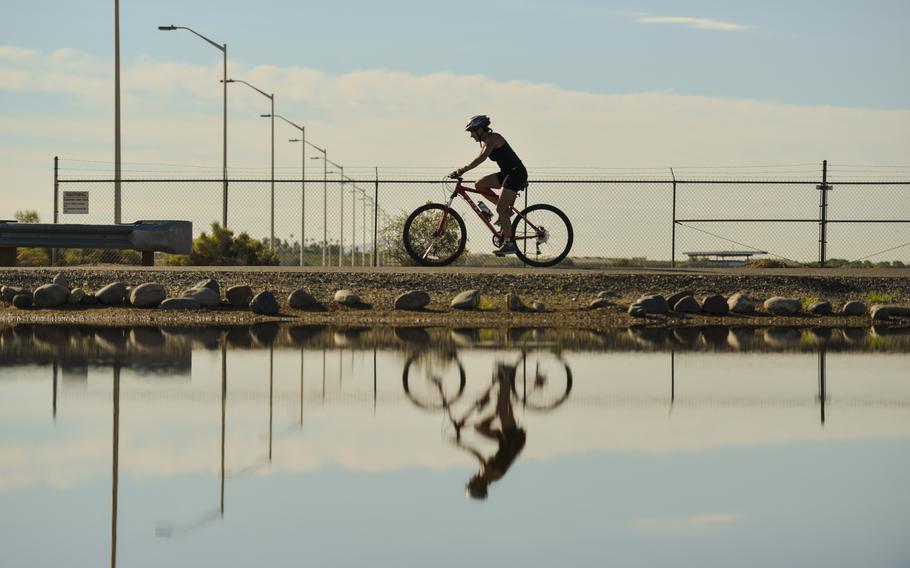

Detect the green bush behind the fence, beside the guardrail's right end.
[{"left": 166, "top": 222, "right": 278, "bottom": 266}]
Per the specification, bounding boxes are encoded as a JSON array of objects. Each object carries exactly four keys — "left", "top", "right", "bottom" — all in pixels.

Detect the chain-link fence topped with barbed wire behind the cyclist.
[{"left": 35, "top": 160, "right": 910, "bottom": 267}]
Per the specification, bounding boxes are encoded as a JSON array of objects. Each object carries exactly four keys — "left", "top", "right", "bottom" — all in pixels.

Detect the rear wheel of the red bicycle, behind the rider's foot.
[{"left": 512, "top": 203, "right": 574, "bottom": 266}]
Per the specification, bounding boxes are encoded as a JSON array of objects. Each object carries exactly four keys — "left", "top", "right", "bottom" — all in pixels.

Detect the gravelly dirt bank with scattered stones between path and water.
[{"left": 0, "top": 267, "right": 910, "bottom": 328}]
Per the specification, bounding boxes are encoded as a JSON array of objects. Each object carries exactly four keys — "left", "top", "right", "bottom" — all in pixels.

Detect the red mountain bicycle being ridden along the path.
[{"left": 404, "top": 177, "right": 574, "bottom": 267}]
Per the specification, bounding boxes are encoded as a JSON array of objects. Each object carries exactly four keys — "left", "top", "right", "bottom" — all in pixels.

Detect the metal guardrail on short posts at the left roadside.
[{"left": 0, "top": 221, "right": 193, "bottom": 266}]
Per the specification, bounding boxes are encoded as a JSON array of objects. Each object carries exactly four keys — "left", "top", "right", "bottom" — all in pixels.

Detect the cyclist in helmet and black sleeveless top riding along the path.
[{"left": 451, "top": 114, "right": 528, "bottom": 256}]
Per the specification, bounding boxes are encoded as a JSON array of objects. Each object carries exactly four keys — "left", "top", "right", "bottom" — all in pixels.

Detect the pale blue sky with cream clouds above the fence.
[{"left": 0, "top": 0, "right": 910, "bottom": 254}]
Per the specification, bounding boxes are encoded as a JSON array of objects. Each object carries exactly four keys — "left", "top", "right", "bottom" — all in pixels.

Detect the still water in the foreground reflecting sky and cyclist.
[{"left": 0, "top": 325, "right": 910, "bottom": 567}]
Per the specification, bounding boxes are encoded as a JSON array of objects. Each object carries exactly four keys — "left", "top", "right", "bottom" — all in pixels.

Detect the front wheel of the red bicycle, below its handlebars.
[{"left": 404, "top": 203, "right": 468, "bottom": 266}]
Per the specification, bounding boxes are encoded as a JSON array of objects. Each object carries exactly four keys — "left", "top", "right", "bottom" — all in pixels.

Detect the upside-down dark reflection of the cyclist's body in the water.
[{"left": 456, "top": 364, "right": 527, "bottom": 499}]
